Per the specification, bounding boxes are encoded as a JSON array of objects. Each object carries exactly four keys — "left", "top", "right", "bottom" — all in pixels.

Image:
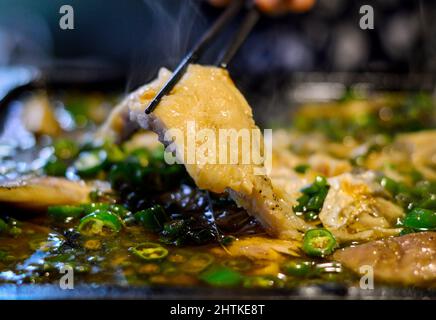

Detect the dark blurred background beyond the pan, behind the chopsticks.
[{"left": 0, "top": 0, "right": 436, "bottom": 90}]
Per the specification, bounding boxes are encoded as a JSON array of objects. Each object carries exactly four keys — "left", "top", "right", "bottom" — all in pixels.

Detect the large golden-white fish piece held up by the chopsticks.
[{"left": 124, "top": 65, "right": 310, "bottom": 239}]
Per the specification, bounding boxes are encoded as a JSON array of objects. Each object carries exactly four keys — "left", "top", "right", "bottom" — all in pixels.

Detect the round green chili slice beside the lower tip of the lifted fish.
[{"left": 303, "top": 229, "right": 336, "bottom": 257}]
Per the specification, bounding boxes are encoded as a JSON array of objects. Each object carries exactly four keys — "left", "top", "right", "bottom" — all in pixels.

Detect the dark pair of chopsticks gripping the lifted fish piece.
[{"left": 145, "top": 0, "right": 260, "bottom": 114}]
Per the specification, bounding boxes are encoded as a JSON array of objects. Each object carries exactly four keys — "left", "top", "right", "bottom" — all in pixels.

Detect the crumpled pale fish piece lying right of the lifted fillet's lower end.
[{"left": 319, "top": 171, "right": 404, "bottom": 242}]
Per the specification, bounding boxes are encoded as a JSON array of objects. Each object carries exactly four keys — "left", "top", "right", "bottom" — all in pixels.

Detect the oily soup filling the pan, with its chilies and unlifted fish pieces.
[{"left": 0, "top": 80, "right": 436, "bottom": 288}]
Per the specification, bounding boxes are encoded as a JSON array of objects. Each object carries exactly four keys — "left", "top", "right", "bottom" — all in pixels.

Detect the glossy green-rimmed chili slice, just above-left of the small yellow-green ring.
[{"left": 78, "top": 210, "right": 122, "bottom": 237}]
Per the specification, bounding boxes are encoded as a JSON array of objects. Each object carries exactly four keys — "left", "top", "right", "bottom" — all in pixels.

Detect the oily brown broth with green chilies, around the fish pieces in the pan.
[{"left": 0, "top": 89, "right": 436, "bottom": 288}]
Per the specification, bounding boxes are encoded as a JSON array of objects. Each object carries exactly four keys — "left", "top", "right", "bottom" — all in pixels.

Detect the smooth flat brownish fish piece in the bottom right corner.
[{"left": 333, "top": 232, "right": 436, "bottom": 286}]
